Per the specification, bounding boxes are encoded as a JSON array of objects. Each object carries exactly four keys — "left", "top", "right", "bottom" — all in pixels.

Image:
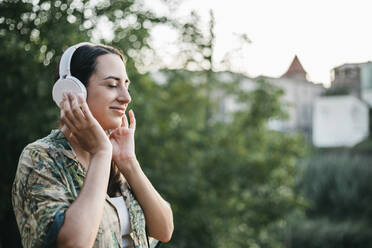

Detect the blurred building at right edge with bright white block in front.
[{"left": 313, "top": 62, "right": 372, "bottom": 147}]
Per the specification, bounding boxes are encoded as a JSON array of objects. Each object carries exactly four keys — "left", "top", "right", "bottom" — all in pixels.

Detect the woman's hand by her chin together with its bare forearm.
[{"left": 110, "top": 110, "right": 174, "bottom": 242}]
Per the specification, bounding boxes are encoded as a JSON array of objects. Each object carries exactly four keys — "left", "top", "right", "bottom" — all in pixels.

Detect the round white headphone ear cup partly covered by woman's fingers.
[{"left": 52, "top": 76, "right": 87, "bottom": 107}]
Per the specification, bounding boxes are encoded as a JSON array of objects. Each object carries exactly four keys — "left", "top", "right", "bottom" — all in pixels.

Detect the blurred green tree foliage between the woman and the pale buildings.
[{"left": 129, "top": 70, "right": 303, "bottom": 247}]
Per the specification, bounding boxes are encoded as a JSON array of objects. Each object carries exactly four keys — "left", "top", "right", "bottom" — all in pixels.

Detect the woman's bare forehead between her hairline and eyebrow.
[{"left": 95, "top": 54, "right": 127, "bottom": 79}]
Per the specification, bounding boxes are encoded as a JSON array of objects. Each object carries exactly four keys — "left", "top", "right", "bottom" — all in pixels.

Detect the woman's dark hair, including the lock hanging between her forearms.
[{"left": 58, "top": 45, "right": 125, "bottom": 197}]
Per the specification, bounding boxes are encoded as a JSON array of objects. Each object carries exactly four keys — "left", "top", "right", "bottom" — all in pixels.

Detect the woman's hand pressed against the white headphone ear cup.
[{"left": 60, "top": 92, "right": 112, "bottom": 155}]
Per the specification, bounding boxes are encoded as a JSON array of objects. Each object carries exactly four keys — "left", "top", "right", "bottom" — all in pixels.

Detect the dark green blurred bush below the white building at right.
[{"left": 287, "top": 152, "right": 372, "bottom": 248}]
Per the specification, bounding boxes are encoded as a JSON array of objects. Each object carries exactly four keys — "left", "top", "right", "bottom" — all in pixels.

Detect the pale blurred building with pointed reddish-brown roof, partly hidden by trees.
[{"left": 151, "top": 56, "right": 324, "bottom": 140}]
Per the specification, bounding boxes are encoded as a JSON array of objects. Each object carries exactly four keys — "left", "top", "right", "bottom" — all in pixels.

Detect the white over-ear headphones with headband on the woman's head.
[{"left": 52, "top": 42, "right": 93, "bottom": 107}]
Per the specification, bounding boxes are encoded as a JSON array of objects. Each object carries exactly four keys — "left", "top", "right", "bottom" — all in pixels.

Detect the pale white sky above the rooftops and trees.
[{"left": 146, "top": 0, "right": 372, "bottom": 87}]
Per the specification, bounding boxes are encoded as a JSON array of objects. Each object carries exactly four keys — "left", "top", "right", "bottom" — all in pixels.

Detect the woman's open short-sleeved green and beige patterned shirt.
[{"left": 12, "top": 130, "right": 157, "bottom": 248}]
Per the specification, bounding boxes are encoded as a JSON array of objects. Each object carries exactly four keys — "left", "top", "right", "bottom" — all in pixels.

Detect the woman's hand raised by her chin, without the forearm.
[{"left": 110, "top": 110, "right": 136, "bottom": 165}]
